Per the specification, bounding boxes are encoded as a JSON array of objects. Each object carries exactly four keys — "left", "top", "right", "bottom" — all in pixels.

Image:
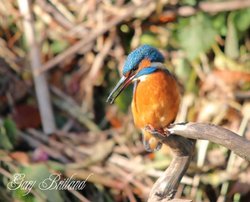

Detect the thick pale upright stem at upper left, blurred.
[{"left": 18, "top": 0, "right": 56, "bottom": 134}]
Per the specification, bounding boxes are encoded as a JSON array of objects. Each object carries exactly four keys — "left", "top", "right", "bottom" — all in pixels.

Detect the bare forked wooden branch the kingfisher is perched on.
[{"left": 148, "top": 123, "right": 250, "bottom": 202}]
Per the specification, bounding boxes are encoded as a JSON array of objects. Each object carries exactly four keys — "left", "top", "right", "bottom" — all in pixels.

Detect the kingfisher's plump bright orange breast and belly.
[{"left": 132, "top": 71, "right": 180, "bottom": 129}]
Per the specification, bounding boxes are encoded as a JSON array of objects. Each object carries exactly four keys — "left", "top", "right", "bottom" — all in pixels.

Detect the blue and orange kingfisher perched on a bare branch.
[{"left": 107, "top": 45, "right": 180, "bottom": 152}]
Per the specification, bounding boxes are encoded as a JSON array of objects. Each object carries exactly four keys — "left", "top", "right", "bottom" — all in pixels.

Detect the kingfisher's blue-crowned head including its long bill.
[{"left": 107, "top": 45, "right": 164, "bottom": 103}]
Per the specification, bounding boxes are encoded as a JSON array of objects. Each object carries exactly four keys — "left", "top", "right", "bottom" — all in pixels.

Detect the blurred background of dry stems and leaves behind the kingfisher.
[{"left": 0, "top": 0, "right": 250, "bottom": 202}]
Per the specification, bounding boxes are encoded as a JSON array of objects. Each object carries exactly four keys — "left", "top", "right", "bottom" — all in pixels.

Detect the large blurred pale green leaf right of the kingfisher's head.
[{"left": 178, "top": 13, "right": 216, "bottom": 60}]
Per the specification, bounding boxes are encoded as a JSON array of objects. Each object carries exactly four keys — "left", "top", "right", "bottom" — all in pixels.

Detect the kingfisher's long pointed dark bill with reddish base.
[{"left": 106, "top": 76, "right": 134, "bottom": 104}]
